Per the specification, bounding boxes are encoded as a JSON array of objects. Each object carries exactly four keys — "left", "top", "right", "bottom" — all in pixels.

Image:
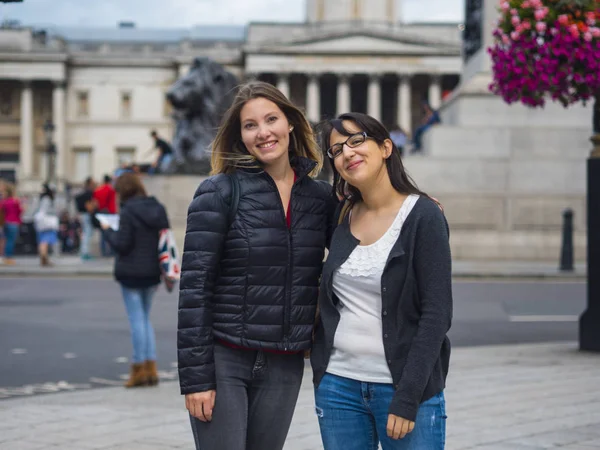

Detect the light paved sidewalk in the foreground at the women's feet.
[{"left": 0, "top": 343, "right": 600, "bottom": 450}]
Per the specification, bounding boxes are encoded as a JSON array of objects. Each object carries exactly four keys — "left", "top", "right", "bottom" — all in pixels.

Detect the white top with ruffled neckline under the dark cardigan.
[{"left": 327, "top": 195, "right": 419, "bottom": 383}]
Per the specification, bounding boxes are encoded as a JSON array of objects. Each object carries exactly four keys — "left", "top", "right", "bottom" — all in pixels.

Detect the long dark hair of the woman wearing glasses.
[{"left": 319, "top": 113, "right": 429, "bottom": 205}]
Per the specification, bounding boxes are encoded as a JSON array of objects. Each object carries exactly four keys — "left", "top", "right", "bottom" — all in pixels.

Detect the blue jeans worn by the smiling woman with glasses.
[{"left": 315, "top": 373, "right": 446, "bottom": 450}]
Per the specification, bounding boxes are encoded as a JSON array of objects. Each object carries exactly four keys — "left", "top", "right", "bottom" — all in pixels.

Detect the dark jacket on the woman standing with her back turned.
[{"left": 103, "top": 197, "right": 169, "bottom": 288}]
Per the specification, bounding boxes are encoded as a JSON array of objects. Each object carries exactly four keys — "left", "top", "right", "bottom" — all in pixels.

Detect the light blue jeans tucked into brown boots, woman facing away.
[{"left": 121, "top": 286, "right": 156, "bottom": 363}]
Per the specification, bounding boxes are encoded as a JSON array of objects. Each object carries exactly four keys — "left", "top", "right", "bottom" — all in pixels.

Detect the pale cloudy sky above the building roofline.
[{"left": 0, "top": 0, "right": 464, "bottom": 28}]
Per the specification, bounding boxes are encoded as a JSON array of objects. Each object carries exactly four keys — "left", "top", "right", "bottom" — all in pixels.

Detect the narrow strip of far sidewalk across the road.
[{"left": 0, "top": 255, "right": 587, "bottom": 280}]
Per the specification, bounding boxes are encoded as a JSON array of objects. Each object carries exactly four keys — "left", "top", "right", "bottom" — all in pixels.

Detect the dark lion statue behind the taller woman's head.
[{"left": 167, "top": 58, "right": 238, "bottom": 174}]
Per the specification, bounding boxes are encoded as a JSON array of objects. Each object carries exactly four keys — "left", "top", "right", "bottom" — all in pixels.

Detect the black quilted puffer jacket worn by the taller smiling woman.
[{"left": 177, "top": 158, "right": 335, "bottom": 394}]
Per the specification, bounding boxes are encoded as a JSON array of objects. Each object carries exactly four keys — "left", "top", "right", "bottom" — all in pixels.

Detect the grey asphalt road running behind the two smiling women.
[{"left": 0, "top": 277, "right": 586, "bottom": 398}]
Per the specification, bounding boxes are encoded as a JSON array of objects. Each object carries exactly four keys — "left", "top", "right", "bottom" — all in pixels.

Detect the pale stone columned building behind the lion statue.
[{"left": 0, "top": 0, "right": 461, "bottom": 190}]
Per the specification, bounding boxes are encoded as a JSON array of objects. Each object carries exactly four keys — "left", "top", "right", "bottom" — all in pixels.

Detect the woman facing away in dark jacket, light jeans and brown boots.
[{"left": 101, "top": 173, "right": 169, "bottom": 388}]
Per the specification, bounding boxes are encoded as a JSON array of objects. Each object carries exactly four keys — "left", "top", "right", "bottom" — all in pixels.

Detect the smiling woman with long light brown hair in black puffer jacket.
[{"left": 177, "top": 81, "right": 335, "bottom": 450}]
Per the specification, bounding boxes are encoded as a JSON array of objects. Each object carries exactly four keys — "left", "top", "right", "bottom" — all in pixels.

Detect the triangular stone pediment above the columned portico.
[{"left": 246, "top": 31, "right": 461, "bottom": 55}]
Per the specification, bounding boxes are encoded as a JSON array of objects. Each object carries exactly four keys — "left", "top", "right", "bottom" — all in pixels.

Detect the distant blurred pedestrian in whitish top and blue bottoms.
[{"left": 33, "top": 183, "right": 58, "bottom": 266}]
